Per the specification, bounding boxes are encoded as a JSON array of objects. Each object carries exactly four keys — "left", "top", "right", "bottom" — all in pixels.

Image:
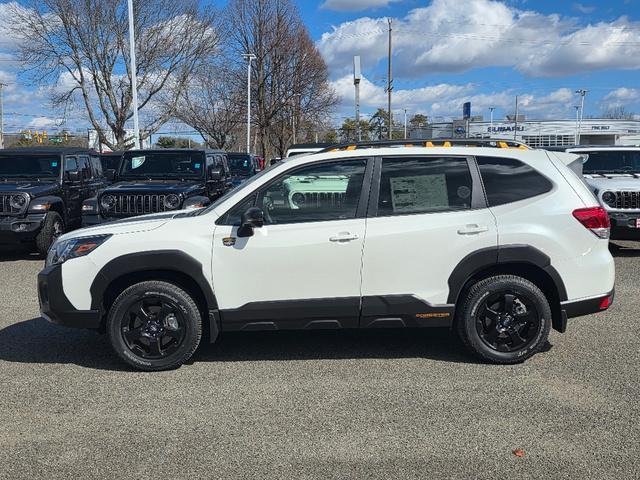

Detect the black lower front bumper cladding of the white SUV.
[{"left": 38, "top": 265, "right": 102, "bottom": 329}]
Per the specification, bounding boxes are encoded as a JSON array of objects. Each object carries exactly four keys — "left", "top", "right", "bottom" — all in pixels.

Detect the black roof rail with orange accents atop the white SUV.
[{"left": 318, "top": 138, "right": 530, "bottom": 153}]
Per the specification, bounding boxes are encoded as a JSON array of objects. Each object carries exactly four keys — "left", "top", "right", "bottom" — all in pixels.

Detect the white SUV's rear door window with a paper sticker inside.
[{"left": 378, "top": 157, "right": 473, "bottom": 216}]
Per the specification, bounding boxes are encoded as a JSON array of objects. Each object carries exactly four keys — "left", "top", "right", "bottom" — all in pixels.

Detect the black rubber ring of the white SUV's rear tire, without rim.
[{"left": 463, "top": 279, "right": 551, "bottom": 363}]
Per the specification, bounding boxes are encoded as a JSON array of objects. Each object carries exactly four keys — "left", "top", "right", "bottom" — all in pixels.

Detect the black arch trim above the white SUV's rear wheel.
[{"left": 447, "top": 245, "right": 567, "bottom": 304}]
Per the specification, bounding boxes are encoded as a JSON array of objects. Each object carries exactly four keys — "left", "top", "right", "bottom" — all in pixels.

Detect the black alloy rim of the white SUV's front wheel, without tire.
[{"left": 120, "top": 296, "right": 186, "bottom": 359}]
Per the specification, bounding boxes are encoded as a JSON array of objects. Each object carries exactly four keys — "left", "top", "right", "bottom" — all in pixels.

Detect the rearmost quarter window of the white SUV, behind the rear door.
[{"left": 477, "top": 157, "right": 553, "bottom": 207}]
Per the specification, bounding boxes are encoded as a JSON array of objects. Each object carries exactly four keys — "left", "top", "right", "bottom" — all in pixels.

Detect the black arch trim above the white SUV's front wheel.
[{"left": 90, "top": 250, "right": 218, "bottom": 311}]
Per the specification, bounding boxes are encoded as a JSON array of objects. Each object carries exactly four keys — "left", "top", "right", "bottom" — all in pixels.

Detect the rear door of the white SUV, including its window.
[{"left": 360, "top": 156, "right": 498, "bottom": 327}]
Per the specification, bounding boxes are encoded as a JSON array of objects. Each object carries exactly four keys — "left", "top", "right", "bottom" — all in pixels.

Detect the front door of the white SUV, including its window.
[{"left": 213, "top": 159, "right": 370, "bottom": 330}]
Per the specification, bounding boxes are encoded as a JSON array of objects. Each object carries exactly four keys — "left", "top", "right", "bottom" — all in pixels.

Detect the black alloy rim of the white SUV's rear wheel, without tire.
[{"left": 476, "top": 290, "right": 541, "bottom": 352}]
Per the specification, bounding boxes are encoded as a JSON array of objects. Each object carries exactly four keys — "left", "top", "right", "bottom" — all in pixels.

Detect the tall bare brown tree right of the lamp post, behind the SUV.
[{"left": 225, "top": 0, "right": 337, "bottom": 158}]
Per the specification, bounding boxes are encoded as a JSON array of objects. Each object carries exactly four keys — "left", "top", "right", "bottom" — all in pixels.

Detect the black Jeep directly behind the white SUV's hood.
[{"left": 82, "top": 149, "right": 231, "bottom": 226}]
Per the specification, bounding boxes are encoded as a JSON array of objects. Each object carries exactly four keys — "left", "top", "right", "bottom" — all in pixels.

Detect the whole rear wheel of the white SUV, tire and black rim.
[{"left": 457, "top": 275, "right": 551, "bottom": 364}]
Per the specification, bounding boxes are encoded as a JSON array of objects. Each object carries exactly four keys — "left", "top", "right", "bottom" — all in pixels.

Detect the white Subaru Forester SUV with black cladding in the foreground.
[{"left": 38, "top": 140, "right": 615, "bottom": 370}]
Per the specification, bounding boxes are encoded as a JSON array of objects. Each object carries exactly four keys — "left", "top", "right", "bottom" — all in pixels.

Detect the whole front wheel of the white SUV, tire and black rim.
[{"left": 107, "top": 281, "right": 202, "bottom": 371}]
